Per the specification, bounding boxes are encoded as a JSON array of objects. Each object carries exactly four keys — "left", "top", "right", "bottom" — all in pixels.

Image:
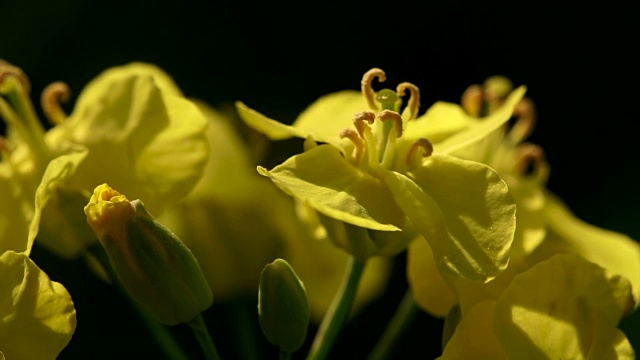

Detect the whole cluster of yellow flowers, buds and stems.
[{"left": 0, "top": 62, "right": 640, "bottom": 359}]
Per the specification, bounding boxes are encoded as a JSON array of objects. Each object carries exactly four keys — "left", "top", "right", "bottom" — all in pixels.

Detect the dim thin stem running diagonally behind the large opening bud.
[{"left": 88, "top": 245, "right": 189, "bottom": 360}]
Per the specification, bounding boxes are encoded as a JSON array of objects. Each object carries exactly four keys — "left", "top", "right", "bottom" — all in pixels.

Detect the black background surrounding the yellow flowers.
[{"left": 0, "top": 0, "right": 640, "bottom": 358}]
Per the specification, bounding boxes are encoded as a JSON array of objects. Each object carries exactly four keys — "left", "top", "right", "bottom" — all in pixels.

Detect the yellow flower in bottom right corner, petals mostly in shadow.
[{"left": 439, "top": 255, "right": 635, "bottom": 360}]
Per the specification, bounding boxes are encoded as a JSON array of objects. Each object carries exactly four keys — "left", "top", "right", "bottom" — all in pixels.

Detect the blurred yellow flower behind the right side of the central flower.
[{"left": 407, "top": 78, "right": 640, "bottom": 317}]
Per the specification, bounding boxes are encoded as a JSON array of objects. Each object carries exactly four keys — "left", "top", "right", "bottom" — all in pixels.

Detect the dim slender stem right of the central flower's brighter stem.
[{"left": 368, "top": 291, "right": 419, "bottom": 360}]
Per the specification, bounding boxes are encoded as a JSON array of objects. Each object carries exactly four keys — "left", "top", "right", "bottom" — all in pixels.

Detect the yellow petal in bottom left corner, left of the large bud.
[{"left": 0, "top": 251, "right": 76, "bottom": 360}]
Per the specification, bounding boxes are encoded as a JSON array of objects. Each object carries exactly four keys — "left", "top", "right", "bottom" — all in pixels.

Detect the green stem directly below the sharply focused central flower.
[{"left": 307, "top": 256, "right": 364, "bottom": 360}]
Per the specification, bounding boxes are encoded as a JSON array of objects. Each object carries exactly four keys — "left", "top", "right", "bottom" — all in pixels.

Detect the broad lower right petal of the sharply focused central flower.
[{"left": 384, "top": 153, "right": 516, "bottom": 282}]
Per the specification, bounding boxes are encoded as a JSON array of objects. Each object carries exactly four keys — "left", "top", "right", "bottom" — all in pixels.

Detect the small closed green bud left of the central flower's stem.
[{"left": 258, "top": 259, "right": 309, "bottom": 353}]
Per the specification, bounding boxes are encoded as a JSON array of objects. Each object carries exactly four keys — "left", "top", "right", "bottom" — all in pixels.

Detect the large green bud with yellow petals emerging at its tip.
[{"left": 84, "top": 184, "right": 213, "bottom": 325}]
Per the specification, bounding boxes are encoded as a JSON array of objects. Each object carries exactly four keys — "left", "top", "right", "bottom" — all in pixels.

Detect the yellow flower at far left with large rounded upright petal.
[{"left": 0, "top": 62, "right": 208, "bottom": 258}]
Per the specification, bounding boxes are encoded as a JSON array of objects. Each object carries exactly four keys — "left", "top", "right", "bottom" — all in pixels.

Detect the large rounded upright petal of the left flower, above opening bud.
[{"left": 46, "top": 64, "right": 208, "bottom": 213}]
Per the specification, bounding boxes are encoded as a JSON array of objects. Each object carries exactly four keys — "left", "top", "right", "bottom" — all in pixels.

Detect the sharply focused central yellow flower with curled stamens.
[{"left": 237, "top": 69, "right": 524, "bottom": 281}]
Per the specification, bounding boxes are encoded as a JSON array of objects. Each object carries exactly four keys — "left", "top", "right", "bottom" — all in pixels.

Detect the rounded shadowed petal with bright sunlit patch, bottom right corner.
[{"left": 494, "top": 254, "right": 633, "bottom": 359}]
